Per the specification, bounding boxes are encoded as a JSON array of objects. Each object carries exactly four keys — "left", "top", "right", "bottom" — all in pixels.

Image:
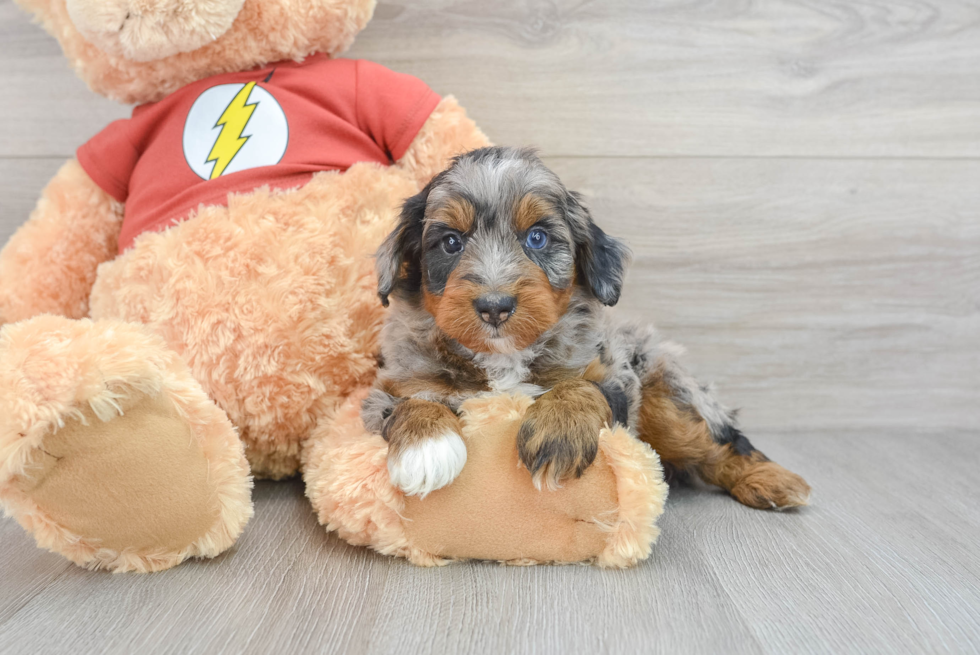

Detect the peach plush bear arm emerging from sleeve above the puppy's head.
[{"left": 396, "top": 96, "right": 491, "bottom": 187}]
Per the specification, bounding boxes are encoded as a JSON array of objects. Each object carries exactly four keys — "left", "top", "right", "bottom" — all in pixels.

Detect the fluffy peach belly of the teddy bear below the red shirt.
[{"left": 91, "top": 164, "right": 424, "bottom": 478}]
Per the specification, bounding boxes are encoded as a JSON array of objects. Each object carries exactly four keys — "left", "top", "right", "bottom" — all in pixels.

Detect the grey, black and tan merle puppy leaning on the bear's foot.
[{"left": 362, "top": 148, "right": 810, "bottom": 509}]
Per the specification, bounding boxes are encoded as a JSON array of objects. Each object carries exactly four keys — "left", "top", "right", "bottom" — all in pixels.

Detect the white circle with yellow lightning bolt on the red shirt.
[{"left": 183, "top": 82, "right": 289, "bottom": 180}]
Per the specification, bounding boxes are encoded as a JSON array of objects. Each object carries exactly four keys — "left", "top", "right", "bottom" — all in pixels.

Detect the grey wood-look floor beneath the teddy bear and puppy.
[{"left": 0, "top": 430, "right": 980, "bottom": 654}]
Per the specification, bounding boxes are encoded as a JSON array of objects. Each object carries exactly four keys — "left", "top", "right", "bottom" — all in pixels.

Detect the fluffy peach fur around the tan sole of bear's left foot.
[{"left": 0, "top": 315, "right": 252, "bottom": 571}]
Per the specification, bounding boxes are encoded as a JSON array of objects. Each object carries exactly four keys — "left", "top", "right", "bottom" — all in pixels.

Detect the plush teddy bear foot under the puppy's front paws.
[{"left": 303, "top": 389, "right": 667, "bottom": 568}]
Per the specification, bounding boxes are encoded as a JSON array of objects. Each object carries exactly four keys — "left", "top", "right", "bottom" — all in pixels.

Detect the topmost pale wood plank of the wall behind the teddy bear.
[{"left": 0, "top": 0, "right": 980, "bottom": 157}]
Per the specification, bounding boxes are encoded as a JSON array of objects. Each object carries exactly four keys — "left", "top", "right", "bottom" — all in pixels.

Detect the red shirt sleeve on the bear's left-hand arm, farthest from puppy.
[{"left": 75, "top": 119, "right": 139, "bottom": 202}]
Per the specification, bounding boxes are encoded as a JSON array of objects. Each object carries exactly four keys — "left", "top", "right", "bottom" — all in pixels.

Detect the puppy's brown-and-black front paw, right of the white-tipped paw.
[{"left": 517, "top": 380, "right": 612, "bottom": 491}]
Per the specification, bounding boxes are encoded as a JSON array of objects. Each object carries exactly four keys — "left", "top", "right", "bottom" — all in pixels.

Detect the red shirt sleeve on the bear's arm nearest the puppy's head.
[{"left": 355, "top": 60, "right": 441, "bottom": 161}]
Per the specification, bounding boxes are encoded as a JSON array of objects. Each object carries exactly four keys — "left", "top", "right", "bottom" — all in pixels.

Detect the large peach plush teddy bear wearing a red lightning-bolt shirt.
[{"left": 0, "top": 0, "right": 665, "bottom": 571}]
